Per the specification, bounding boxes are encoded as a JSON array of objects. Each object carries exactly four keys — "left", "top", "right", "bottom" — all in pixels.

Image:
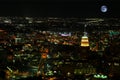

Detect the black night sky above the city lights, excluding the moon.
[{"left": 0, "top": 0, "right": 120, "bottom": 17}]
